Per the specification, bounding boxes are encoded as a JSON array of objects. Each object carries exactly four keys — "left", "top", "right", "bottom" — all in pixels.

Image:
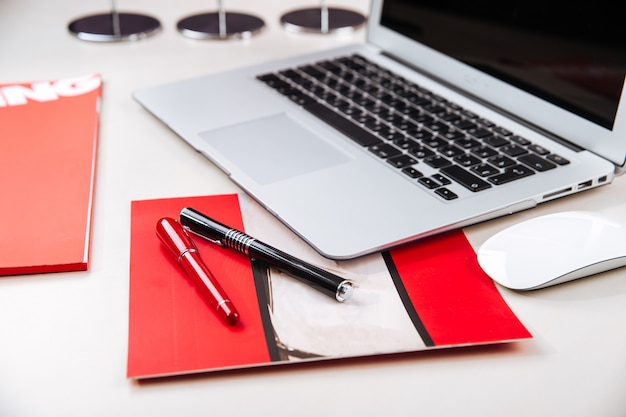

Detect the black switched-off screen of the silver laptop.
[{"left": 380, "top": 0, "right": 626, "bottom": 129}]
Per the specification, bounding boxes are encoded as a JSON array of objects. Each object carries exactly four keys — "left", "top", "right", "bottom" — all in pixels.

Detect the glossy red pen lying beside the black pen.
[{"left": 156, "top": 217, "right": 239, "bottom": 326}]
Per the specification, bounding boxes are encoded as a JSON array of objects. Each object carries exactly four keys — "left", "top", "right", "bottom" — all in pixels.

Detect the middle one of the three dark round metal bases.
[{"left": 176, "top": 12, "right": 265, "bottom": 39}]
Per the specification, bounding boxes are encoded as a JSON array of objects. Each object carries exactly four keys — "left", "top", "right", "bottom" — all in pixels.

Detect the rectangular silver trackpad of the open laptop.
[{"left": 200, "top": 114, "right": 350, "bottom": 184}]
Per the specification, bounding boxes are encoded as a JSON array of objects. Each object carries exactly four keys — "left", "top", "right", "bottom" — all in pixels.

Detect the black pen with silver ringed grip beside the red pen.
[{"left": 180, "top": 207, "right": 355, "bottom": 302}]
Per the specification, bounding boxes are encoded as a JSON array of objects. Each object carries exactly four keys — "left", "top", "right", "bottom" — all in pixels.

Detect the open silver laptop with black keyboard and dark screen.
[{"left": 134, "top": 0, "right": 626, "bottom": 260}]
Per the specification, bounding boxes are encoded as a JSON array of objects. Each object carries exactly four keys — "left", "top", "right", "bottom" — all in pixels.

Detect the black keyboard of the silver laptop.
[{"left": 257, "top": 55, "right": 569, "bottom": 200}]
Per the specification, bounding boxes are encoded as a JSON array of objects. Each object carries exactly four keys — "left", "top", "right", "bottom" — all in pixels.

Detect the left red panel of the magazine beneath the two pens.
[{"left": 128, "top": 195, "right": 269, "bottom": 377}]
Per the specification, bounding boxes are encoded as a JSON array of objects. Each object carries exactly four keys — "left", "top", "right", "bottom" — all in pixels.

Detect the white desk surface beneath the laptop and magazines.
[{"left": 0, "top": 0, "right": 626, "bottom": 417}]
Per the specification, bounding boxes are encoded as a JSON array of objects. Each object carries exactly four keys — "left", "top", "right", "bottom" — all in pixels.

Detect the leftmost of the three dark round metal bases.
[{"left": 68, "top": 13, "right": 161, "bottom": 42}]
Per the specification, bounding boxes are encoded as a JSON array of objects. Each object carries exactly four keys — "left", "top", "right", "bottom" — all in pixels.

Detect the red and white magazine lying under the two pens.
[{"left": 127, "top": 194, "right": 532, "bottom": 379}]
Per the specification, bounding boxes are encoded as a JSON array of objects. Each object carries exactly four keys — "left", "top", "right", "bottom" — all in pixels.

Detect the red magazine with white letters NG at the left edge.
[{"left": 0, "top": 75, "right": 102, "bottom": 275}]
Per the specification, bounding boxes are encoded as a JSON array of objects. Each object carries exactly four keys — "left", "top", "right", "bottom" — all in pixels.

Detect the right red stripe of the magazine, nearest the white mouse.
[{"left": 390, "top": 231, "right": 531, "bottom": 346}]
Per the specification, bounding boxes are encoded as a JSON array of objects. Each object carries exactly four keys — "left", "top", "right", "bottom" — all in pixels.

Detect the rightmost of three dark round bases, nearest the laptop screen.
[{"left": 280, "top": 7, "right": 366, "bottom": 33}]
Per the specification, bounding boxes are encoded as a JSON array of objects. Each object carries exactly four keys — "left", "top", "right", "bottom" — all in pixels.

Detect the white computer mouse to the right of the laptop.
[{"left": 478, "top": 211, "right": 626, "bottom": 290}]
